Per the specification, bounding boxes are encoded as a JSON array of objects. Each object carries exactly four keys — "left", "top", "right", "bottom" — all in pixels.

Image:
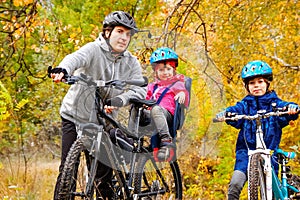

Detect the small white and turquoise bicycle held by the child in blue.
[{"left": 213, "top": 104, "right": 300, "bottom": 200}]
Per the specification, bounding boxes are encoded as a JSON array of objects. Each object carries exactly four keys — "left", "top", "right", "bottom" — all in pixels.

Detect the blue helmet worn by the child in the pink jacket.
[{"left": 150, "top": 47, "right": 178, "bottom": 67}]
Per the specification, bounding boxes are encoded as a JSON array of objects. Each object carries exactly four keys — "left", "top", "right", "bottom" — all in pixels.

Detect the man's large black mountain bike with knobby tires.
[{"left": 59, "top": 74, "right": 182, "bottom": 200}]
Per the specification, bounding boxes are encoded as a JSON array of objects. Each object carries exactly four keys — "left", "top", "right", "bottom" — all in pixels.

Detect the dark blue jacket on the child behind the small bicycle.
[{"left": 226, "top": 91, "right": 298, "bottom": 174}]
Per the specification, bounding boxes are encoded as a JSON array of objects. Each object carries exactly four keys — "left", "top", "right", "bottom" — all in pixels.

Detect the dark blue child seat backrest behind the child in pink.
[{"left": 169, "top": 76, "right": 192, "bottom": 138}]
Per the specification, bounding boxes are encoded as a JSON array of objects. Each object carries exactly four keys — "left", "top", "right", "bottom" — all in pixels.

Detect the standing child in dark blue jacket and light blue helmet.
[{"left": 217, "top": 60, "right": 298, "bottom": 200}]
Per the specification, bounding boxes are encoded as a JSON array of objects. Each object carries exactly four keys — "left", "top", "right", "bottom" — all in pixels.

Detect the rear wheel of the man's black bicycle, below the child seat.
[{"left": 134, "top": 155, "right": 182, "bottom": 200}]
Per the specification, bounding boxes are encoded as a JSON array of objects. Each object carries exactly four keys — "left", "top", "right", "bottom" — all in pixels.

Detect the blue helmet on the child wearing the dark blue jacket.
[{"left": 242, "top": 60, "right": 273, "bottom": 83}]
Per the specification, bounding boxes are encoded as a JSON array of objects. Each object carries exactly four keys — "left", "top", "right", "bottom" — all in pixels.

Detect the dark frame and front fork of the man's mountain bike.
[{"left": 74, "top": 93, "right": 147, "bottom": 199}]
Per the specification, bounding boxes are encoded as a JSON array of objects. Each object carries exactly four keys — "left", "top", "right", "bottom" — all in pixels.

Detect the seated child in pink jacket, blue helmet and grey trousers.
[{"left": 146, "top": 47, "right": 189, "bottom": 160}]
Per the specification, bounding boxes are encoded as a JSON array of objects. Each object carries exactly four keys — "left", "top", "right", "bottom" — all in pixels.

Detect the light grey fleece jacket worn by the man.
[{"left": 58, "top": 34, "right": 146, "bottom": 124}]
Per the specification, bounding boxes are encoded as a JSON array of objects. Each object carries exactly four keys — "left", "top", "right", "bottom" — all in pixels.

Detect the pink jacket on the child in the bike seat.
[{"left": 146, "top": 74, "right": 189, "bottom": 115}]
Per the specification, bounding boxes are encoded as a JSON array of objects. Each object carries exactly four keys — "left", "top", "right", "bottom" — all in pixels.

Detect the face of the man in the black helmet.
[{"left": 105, "top": 26, "right": 131, "bottom": 53}]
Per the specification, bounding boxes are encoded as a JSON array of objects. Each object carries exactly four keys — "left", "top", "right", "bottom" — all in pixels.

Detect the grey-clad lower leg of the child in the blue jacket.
[{"left": 228, "top": 170, "right": 247, "bottom": 200}]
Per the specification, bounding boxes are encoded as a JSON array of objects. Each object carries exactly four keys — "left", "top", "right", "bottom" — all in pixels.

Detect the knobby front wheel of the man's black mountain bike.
[{"left": 58, "top": 138, "right": 95, "bottom": 200}]
